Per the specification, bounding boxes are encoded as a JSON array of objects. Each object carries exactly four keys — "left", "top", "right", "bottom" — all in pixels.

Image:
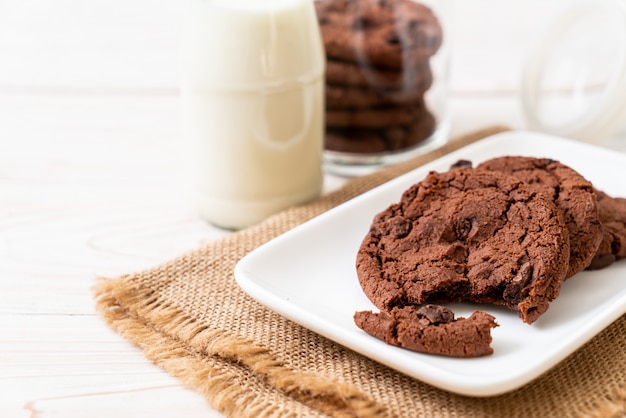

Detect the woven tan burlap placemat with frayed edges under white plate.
[{"left": 94, "top": 127, "right": 626, "bottom": 418}]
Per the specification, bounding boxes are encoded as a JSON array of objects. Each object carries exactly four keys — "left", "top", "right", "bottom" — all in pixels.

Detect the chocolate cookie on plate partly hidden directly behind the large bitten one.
[{"left": 476, "top": 156, "right": 603, "bottom": 278}]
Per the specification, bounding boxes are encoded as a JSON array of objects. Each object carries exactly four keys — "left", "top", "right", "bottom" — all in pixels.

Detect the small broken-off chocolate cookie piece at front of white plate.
[{"left": 354, "top": 305, "right": 498, "bottom": 357}]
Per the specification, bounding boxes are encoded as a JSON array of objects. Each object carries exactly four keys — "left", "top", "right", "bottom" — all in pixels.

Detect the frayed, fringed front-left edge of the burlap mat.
[{"left": 95, "top": 277, "right": 384, "bottom": 417}]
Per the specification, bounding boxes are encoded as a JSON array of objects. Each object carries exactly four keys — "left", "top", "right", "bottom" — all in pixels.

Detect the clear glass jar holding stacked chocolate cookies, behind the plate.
[{"left": 315, "top": 0, "right": 450, "bottom": 175}]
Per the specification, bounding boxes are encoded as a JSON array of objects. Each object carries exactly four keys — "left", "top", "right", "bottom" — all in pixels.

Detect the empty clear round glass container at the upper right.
[{"left": 522, "top": 0, "right": 626, "bottom": 142}]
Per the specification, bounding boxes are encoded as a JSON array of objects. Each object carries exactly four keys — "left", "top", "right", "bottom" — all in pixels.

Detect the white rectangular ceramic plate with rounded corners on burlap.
[{"left": 235, "top": 131, "right": 626, "bottom": 396}]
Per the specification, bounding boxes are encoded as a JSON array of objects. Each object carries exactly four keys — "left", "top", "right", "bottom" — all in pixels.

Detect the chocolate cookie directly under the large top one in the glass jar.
[{"left": 326, "top": 59, "right": 433, "bottom": 90}]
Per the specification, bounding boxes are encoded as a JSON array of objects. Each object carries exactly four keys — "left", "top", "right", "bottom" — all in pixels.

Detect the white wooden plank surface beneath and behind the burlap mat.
[{"left": 0, "top": 0, "right": 626, "bottom": 418}]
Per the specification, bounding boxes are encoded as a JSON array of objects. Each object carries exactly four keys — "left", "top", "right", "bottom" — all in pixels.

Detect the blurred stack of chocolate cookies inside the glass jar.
[{"left": 315, "top": 0, "right": 442, "bottom": 153}]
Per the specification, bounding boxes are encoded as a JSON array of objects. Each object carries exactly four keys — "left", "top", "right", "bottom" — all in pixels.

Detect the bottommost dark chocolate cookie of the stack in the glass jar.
[{"left": 325, "top": 113, "right": 436, "bottom": 154}]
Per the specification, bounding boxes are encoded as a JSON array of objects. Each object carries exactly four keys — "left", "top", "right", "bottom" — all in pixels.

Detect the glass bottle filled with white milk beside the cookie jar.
[{"left": 181, "top": 0, "right": 325, "bottom": 229}]
